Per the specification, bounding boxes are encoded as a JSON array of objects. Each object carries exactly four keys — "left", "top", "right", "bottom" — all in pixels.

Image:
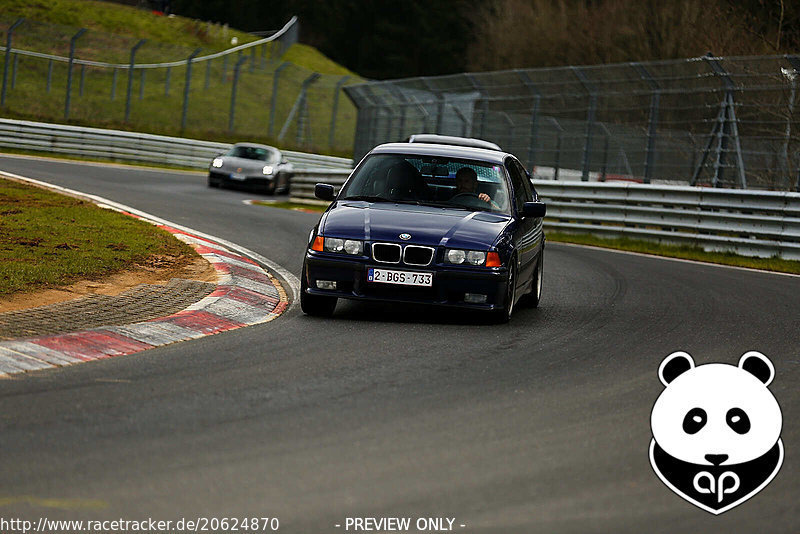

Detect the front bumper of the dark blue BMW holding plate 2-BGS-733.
[{"left": 304, "top": 250, "right": 508, "bottom": 311}]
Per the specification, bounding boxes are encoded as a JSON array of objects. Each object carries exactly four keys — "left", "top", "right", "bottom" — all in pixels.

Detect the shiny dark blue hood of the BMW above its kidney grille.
[{"left": 320, "top": 201, "right": 511, "bottom": 250}]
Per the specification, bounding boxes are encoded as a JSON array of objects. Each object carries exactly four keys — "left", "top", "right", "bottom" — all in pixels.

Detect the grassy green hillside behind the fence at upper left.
[{"left": 0, "top": 0, "right": 361, "bottom": 154}]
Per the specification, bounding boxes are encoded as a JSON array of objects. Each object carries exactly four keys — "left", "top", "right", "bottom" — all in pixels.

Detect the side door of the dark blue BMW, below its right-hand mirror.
[{"left": 506, "top": 157, "right": 541, "bottom": 287}]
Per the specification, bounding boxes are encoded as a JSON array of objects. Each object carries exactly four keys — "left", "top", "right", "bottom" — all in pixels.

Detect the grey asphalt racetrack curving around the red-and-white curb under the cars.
[{"left": 0, "top": 157, "right": 800, "bottom": 533}]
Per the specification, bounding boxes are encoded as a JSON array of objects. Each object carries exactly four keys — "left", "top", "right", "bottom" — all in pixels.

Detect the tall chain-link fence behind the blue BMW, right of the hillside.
[{"left": 345, "top": 56, "right": 800, "bottom": 190}]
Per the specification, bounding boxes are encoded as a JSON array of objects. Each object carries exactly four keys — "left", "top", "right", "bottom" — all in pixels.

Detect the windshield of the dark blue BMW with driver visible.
[{"left": 339, "top": 154, "right": 510, "bottom": 214}]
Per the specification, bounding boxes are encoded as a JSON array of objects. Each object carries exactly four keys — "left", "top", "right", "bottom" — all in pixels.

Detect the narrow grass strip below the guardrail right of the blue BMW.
[{"left": 547, "top": 231, "right": 800, "bottom": 274}]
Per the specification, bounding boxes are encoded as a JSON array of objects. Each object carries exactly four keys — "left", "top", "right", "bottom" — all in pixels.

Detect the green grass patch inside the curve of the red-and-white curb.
[{"left": 0, "top": 179, "right": 195, "bottom": 297}]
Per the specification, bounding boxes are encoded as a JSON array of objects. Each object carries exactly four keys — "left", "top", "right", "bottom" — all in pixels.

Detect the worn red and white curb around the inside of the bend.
[{"left": 0, "top": 173, "right": 298, "bottom": 378}]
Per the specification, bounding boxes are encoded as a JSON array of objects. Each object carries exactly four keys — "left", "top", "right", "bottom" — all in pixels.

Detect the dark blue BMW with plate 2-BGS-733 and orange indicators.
[{"left": 300, "top": 140, "right": 545, "bottom": 322}]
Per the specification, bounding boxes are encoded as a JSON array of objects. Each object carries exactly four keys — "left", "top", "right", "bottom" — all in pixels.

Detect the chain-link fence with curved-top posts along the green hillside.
[{"left": 0, "top": 17, "right": 360, "bottom": 153}]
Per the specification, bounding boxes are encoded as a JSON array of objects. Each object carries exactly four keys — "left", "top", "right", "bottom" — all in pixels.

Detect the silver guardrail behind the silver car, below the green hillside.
[{"left": 0, "top": 119, "right": 353, "bottom": 172}]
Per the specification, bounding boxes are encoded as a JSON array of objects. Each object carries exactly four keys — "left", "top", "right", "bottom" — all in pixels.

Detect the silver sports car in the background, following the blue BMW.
[{"left": 208, "top": 143, "right": 293, "bottom": 195}]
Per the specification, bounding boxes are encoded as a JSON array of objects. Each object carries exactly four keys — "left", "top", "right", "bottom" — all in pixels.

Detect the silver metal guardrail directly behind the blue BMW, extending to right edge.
[{"left": 292, "top": 171, "right": 800, "bottom": 260}]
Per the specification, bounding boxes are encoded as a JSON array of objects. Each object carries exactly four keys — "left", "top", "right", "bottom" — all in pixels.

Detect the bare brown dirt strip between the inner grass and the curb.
[{"left": 0, "top": 251, "right": 217, "bottom": 313}]
